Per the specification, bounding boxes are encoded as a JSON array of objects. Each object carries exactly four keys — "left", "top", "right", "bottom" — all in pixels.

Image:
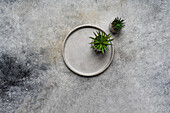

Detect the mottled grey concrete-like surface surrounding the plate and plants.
[{"left": 0, "top": 0, "right": 170, "bottom": 113}]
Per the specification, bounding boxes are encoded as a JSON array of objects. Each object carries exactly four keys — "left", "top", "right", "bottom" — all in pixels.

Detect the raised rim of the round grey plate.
[{"left": 61, "top": 24, "right": 114, "bottom": 77}]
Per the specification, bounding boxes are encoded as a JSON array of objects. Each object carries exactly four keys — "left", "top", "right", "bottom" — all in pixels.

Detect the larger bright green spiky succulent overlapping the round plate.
[{"left": 89, "top": 31, "right": 113, "bottom": 54}]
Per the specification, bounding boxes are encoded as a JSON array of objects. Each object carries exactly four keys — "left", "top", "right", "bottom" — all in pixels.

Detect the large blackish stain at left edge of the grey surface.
[{"left": 0, "top": 54, "right": 49, "bottom": 102}]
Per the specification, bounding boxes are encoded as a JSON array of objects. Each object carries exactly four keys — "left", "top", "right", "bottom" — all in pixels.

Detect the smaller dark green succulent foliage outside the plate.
[{"left": 111, "top": 17, "right": 125, "bottom": 30}]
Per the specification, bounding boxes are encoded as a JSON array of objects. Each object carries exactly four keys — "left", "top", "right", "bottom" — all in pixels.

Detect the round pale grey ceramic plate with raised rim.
[{"left": 62, "top": 25, "right": 114, "bottom": 76}]
